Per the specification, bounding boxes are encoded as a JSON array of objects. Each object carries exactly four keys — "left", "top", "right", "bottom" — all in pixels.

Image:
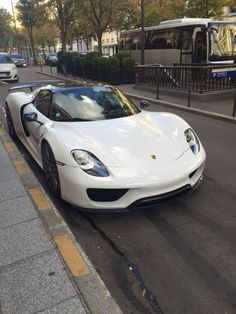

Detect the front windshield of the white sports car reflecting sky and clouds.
[{"left": 53, "top": 86, "right": 140, "bottom": 121}]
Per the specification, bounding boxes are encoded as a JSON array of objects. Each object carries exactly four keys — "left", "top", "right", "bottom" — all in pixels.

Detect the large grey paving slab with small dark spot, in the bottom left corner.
[{"left": 0, "top": 250, "right": 77, "bottom": 314}]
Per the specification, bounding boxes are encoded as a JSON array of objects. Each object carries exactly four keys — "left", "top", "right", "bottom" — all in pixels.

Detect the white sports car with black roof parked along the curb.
[{"left": 6, "top": 81, "right": 206, "bottom": 210}]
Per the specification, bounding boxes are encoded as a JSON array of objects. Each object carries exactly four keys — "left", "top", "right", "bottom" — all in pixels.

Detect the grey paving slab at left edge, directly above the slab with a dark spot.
[{"left": 0, "top": 219, "right": 53, "bottom": 266}]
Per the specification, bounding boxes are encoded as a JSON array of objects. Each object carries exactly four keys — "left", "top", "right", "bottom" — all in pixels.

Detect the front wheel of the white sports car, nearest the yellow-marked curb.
[{"left": 42, "top": 142, "right": 61, "bottom": 198}]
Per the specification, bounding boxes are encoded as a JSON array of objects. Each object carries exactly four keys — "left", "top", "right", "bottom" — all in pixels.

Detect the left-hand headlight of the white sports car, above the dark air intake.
[{"left": 71, "top": 150, "right": 109, "bottom": 177}]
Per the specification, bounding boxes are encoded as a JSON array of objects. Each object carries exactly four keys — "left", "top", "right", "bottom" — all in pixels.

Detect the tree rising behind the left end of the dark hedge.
[{"left": 50, "top": 0, "right": 75, "bottom": 52}]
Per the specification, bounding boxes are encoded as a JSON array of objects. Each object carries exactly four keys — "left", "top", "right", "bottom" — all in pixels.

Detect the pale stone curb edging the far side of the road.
[{"left": 36, "top": 71, "right": 236, "bottom": 123}]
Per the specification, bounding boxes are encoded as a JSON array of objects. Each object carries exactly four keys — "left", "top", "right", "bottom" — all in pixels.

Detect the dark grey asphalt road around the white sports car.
[{"left": 0, "top": 69, "right": 236, "bottom": 314}]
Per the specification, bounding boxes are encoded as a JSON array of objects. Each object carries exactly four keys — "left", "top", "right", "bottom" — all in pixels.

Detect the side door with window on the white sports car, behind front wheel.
[{"left": 23, "top": 89, "right": 52, "bottom": 158}]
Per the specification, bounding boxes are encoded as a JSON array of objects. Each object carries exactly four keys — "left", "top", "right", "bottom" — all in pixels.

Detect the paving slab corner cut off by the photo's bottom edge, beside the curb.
[{"left": 38, "top": 297, "right": 86, "bottom": 314}]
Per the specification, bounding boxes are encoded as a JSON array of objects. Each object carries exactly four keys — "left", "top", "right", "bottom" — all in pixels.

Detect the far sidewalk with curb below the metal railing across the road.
[{"left": 36, "top": 65, "right": 236, "bottom": 123}]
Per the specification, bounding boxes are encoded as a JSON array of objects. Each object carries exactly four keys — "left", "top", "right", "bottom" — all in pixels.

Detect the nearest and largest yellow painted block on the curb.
[{"left": 54, "top": 234, "right": 89, "bottom": 277}]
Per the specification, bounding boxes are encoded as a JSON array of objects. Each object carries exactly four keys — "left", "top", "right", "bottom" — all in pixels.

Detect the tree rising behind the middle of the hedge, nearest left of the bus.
[{"left": 75, "top": 0, "right": 114, "bottom": 53}]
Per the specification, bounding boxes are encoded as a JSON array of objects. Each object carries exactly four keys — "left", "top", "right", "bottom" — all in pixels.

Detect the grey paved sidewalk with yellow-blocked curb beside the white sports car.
[{"left": 0, "top": 125, "right": 121, "bottom": 314}]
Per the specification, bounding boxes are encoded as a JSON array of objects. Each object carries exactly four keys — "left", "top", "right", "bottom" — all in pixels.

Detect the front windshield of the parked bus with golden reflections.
[{"left": 209, "top": 23, "right": 236, "bottom": 61}]
